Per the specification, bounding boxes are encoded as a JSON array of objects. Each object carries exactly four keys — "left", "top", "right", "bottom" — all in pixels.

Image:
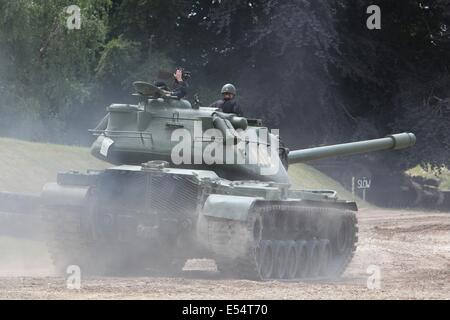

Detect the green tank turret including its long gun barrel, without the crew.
[{"left": 92, "top": 82, "right": 415, "bottom": 183}]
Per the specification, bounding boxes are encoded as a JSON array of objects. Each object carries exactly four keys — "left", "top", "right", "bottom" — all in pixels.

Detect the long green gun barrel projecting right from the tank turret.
[{"left": 289, "top": 133, "right": 416, "bottom": 164}]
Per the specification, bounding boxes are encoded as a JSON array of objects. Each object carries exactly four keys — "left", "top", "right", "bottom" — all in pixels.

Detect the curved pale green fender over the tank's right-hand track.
[{"left": 203, "top": 194, "right": 258, "bottom": 221}]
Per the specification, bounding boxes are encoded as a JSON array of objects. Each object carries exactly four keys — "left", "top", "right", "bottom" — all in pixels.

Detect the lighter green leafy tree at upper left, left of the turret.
[{"left": 0, "top": 0, "right": 110, "bottom": 141}]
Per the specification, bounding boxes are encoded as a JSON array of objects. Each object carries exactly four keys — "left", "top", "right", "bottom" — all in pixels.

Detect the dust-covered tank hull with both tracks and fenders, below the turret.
[{"left": 0, "top": 162, "right": 357, "bottom": 281}]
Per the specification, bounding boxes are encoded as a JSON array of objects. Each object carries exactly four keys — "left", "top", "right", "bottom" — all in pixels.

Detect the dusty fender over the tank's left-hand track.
[{"left": 41, "top": 183, "right": 89, "bottom": 207}]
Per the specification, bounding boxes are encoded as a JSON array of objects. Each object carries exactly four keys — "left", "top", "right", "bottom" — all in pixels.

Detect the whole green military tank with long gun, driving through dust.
[{"left": 0, "top": 82, "right": 415, "bottom": 281}]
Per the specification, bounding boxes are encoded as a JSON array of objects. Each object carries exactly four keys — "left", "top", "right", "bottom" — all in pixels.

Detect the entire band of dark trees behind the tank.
[{"left": 0, "top": 0, "right": 450, "bottom": 172}]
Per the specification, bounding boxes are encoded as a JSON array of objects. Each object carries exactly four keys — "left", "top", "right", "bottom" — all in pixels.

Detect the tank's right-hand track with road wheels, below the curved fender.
[{"left": 209, "top": 204, "right": 358, "bottom": 281}]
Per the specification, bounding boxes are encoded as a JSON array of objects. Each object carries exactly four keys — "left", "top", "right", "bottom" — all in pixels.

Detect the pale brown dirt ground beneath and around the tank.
[{"left": 0, "top": 210, "right": 450, "bottom": 299}]
